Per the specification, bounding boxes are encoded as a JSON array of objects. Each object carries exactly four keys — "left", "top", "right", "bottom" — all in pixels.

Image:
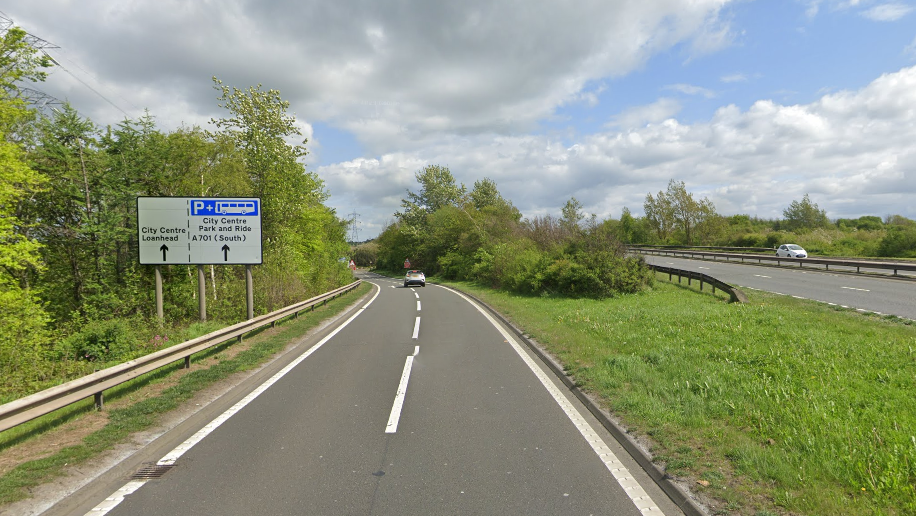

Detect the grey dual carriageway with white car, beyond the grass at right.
[{"left": 645, "top": 256, "right": 916, "bottom": 319}]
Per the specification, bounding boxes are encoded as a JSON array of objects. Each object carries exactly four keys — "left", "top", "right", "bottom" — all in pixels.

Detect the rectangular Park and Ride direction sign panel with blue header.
[{"left": 137, "top": 197, "right": 262, "bottom": 265}]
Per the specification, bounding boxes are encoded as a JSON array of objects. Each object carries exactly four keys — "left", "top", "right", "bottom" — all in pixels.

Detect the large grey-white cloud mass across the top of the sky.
[{"left": 8, "top": 0, "right": 732, "bottom": 153}]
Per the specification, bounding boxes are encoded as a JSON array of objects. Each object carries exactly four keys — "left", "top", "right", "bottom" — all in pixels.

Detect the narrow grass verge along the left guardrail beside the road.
[{"left": 0, "top": 283, "right": 372, "bottom": 507}]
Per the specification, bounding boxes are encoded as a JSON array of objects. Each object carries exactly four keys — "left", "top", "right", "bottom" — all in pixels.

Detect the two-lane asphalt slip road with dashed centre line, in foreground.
[{"left": 48, "top": 276, "right": 682, "bottom": 516}]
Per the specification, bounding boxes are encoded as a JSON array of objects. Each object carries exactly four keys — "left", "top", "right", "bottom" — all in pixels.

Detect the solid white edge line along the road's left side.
[{"left": 86, "top": 283, "right": 382, "bottom": 516}]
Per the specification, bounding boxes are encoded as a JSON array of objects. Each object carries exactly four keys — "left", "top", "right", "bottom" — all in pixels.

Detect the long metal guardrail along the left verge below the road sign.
[{"left": 0, "top": 280, "right": 362, "bottom": 432}]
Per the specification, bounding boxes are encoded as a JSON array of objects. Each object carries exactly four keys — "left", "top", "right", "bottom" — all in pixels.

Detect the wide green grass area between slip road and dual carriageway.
[{"left": 444, "top": 281, "right": 916, "bottom": 515}]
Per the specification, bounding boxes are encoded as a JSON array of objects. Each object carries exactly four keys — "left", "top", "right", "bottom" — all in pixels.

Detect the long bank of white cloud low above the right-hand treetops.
[{"left": 321, "top": 67, "right": 916, "bottom": 235}]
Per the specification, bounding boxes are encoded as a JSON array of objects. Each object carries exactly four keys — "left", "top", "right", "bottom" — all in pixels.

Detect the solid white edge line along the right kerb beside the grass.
[{"left": 452, "top": 290, "right": 664, "bottom": 516}]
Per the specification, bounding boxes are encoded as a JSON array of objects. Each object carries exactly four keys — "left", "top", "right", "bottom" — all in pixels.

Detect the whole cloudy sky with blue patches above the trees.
[{"left": 0, "top": 0, "right": 916, "bottom": 240}]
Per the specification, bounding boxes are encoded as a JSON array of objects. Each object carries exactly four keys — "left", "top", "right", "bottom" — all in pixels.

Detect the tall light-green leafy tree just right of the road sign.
[{"left": 210, "top": 78, "right": 349, "bottom": 308}]
